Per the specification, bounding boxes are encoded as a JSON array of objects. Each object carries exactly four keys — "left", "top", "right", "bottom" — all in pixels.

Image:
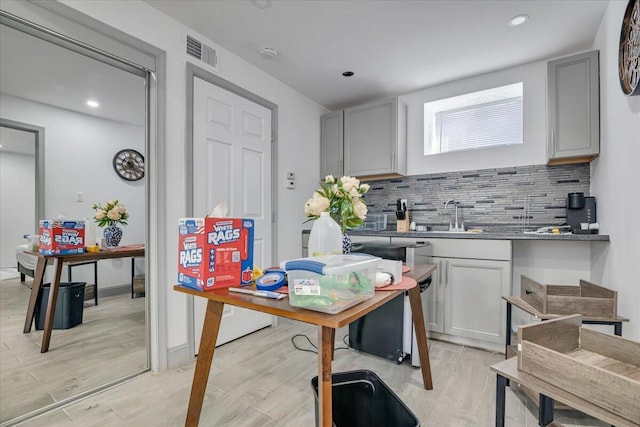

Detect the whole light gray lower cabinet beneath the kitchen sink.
[{"left": 391, "top": 237, "right": 512, "bottom": 351}]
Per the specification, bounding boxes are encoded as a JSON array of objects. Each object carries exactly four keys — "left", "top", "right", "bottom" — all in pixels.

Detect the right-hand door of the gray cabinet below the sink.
[{"left": 441, "top": 258, "right": 511, "bottom": 344}]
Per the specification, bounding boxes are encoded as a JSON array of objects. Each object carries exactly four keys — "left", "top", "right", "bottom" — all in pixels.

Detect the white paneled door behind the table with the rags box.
[{"left": 186, "top": 64, "right": 278, "bottom": 354}]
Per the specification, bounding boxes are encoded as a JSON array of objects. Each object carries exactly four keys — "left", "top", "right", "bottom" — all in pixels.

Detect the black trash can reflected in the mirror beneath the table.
[{"left": 36, "top": 282, "right": 86, "bottom": 331}]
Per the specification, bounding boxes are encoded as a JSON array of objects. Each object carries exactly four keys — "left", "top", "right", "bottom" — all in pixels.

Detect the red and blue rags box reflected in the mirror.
[{"left": 38, "top": 219, "right": 84, "bottom": 255}]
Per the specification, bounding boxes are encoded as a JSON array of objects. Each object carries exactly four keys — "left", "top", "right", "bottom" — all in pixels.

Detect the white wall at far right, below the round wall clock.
[{"left": 591, "top": 1, "right": 640, "bottom": 341}]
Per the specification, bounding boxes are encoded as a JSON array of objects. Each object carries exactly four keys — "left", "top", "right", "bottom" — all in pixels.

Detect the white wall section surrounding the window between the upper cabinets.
[{"left": 400, "top": 61, "right": 547, "bottom": 175}]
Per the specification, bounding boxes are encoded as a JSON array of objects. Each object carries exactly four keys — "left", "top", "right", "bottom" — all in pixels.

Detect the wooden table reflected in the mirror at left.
[{"left": 23, "top": 245, "right": 144, "bottom": 353}]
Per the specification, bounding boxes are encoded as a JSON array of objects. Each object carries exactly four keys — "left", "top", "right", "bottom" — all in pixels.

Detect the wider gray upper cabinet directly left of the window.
[{"left": 344, "top": 97, "right": 407, "bottom": 178}]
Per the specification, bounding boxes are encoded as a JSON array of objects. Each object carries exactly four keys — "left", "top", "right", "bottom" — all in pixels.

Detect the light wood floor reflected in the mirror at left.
[{"left": 0, "top": 278, "right": 147, "bottom": 423}]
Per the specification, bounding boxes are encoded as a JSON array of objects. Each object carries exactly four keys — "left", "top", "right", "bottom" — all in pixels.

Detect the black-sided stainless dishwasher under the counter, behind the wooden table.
[{"left": 349, "top": 241, "right": 432, "bottom": 367}]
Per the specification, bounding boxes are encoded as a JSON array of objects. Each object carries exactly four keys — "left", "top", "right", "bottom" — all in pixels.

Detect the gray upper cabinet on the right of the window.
[{"left": 547, "top": 51, "right": 600, "bottom": 165}]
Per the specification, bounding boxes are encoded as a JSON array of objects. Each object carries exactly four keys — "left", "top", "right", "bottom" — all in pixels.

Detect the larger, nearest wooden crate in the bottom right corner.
[{"left": 518, "top": 315, "right": 640, "bottom": 426}]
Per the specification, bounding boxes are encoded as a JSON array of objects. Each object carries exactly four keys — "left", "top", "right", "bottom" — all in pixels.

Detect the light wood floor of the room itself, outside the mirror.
[{"left": 3, "top": 272, "right": 606, "bottom": 427}]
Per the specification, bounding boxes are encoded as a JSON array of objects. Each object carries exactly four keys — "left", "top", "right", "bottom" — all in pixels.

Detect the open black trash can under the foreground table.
[{"left": 311, "top": 370, "right": 420, "bottom": 427}]
